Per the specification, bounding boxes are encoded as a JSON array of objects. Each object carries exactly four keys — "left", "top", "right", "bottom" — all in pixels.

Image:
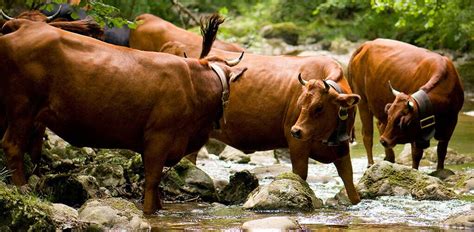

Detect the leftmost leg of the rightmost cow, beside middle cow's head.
[{"left": 358, "top": 101, "right": 374, "bottom": 167}]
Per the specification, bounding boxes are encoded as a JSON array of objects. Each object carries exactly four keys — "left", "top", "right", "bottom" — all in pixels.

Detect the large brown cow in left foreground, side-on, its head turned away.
[{"left": 0, "top": 19, "right": 245, "bottom": 213}]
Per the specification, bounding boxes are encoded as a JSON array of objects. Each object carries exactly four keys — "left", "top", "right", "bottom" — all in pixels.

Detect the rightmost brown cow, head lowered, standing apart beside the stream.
[{"left": 349, "top": 39, "right": 464, "bottom": 170}]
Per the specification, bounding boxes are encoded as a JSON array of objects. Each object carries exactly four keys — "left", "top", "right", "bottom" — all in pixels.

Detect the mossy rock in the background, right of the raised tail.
[{"left": 261, "top": 22, "right": 299, "bottom": 45}]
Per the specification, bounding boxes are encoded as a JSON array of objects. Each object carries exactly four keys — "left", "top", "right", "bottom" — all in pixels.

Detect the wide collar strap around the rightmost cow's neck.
[{"left": 411, "top": 89, "right": 436, "bottom": 148}]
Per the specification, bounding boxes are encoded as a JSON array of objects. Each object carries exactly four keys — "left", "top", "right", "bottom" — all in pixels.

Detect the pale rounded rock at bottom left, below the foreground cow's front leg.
[{"left": 79, "top": 198, "right": 151, "bottom": 231}]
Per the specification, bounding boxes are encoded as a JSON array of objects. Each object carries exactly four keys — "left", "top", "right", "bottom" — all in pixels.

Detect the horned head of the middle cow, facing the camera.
[{"left": 290, "top": 74, "right": 360, "bottom": 141}]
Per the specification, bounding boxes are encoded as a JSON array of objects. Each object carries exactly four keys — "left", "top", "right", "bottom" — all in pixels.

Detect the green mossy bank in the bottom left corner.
[{"left": 0, "top": 182, "right": 56, "bottom": 231}]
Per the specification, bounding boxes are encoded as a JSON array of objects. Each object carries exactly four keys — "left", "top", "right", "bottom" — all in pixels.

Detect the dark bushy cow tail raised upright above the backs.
[{"left": 199, "top": 14, "right": 224, "bottom": 59}]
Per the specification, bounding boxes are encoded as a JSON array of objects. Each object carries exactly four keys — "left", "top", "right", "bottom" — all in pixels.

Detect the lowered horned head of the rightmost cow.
[{"left": 380, "top": 82, "right": 419, "bottom": 148}]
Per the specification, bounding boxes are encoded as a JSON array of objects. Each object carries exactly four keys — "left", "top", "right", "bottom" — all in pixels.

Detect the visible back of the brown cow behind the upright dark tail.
[{"left": 129, "top": 14, "right": 244, "bottom": 57}]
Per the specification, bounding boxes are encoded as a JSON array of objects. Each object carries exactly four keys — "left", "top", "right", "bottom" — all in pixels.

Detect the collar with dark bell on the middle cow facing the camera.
[{"left": 323, "top": 80, "right": 350, "bottom": 146}]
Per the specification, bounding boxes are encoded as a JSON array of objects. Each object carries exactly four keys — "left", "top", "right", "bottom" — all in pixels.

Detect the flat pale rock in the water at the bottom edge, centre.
[{"left": 242, "top": 217, "right": 302, "bottom": 231}]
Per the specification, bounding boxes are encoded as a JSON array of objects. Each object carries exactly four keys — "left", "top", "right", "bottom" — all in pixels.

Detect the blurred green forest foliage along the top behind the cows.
[{"left": 0, "top": 0, "right": 474, "bottom": 53}]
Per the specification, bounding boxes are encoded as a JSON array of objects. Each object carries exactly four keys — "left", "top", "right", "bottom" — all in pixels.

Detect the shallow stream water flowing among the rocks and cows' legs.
[{"left": 149, "top": 114, "right": 474, "bottom": 231}]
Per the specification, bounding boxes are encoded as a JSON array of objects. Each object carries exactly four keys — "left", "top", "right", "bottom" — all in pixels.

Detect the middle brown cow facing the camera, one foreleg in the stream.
[{"left": 163, "top": 42, "right": 360, "bottom": 204}]
